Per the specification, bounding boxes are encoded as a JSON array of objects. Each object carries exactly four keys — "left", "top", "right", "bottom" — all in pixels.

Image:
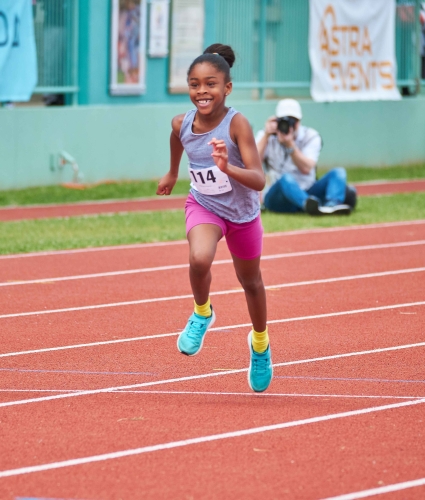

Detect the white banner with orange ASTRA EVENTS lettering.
[{"left": 309, "top": 0, "right": 401, "bottom": 101}]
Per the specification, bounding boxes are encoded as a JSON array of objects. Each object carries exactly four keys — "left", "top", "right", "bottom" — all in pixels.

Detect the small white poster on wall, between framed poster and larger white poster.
[{"left": 149, "top": 0, "right": 170, "bottom": 57}]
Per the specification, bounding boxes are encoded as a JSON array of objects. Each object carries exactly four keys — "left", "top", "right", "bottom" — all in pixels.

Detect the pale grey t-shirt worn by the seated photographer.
[{"left": 255, "top": 125, "right": 322, "bottom": 195}]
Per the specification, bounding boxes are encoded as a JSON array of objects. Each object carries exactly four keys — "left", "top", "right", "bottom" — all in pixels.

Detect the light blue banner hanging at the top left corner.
[{"left": 0, "top": 0, "right": 37, "bottom": 102}]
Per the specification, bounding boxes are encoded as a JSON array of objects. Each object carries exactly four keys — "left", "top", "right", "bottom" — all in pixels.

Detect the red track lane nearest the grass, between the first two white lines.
[{"left": 0, "top": 221, "right": 425, "bottom": 282}]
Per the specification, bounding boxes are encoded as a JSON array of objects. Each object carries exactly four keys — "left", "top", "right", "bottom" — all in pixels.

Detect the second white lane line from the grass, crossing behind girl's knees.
[{"left": 0, "top": 240, "right": 425, "bottom": 287}]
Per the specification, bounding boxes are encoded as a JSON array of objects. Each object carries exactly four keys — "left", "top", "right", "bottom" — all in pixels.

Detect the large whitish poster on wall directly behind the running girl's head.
[{"left": 169, "top": 0, "right": 204, "bottom": 94}]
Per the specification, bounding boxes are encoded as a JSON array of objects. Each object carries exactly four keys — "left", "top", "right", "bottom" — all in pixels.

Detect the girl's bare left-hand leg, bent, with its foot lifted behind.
[{"left": 187, "top": 224, "right": 223, "bottom": 305}]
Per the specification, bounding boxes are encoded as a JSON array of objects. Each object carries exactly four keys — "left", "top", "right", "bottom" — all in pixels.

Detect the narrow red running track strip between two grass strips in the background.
[{"left": 0, "top": 180, "right": 425, "bottom": 221}]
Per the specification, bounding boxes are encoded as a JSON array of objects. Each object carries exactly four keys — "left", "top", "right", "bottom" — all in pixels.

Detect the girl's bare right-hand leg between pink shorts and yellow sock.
[{"left": 232, "top": 254, "right": 267, "bottom": 332}]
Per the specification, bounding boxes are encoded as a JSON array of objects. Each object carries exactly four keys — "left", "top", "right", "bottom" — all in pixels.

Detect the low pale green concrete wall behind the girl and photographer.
[{"left": 0, "top": 97, "right": 425, "bottom": 189}]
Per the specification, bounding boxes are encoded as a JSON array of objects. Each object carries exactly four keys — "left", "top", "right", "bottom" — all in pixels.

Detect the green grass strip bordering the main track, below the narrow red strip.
[{"left": 0, "top": 193, "right": 425, "bottom": 254}]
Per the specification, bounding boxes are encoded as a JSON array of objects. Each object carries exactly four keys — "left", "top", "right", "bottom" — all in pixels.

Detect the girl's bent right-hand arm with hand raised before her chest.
[{"left": 209, "top": 113, "right": 266, "bottom": 191}]
